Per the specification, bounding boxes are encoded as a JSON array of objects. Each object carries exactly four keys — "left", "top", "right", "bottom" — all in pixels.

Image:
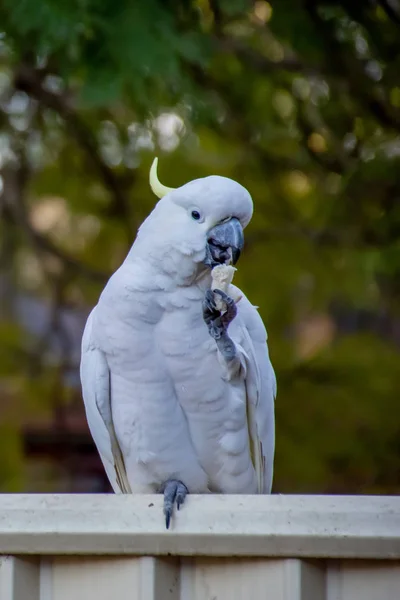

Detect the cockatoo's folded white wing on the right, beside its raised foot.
[{"left": 233, "top": 290, "right": 276, "bottom": 494}]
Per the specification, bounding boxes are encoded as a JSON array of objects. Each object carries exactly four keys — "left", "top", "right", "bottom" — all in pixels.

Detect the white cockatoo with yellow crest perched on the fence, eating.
[{"left": 80, "top": 159, "right": 276, "bottom": 528}]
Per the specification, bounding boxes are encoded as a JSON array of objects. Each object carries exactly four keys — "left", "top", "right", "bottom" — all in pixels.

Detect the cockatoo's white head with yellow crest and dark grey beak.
[{"left": 134, "top": 158, "right": 253, "bottom": 282}]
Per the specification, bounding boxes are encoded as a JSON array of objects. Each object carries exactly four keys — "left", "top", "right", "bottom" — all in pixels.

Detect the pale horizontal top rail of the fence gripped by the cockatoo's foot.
[{"left": 0, "top": 494, "right": 400, "bottom": 559}]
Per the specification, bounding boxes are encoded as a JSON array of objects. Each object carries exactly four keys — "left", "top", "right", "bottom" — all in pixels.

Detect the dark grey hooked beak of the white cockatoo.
[{"left": 204, "top": 217, "right": 244, "bottom": 268}]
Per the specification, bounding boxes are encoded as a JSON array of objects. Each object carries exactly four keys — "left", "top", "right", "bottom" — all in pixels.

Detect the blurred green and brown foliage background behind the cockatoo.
[{"left": 0, "top": 0, "right": 400, "bottom": 494}]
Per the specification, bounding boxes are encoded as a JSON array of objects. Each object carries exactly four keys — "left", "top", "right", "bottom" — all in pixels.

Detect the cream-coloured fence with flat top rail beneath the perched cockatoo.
[{"left": 0, "top": 495, "right": 400, "bottom": 600}]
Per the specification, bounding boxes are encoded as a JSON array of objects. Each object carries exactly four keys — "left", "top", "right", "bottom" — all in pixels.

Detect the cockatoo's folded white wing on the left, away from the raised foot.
[{"left": 80, "top": 309, "right": 132, "bottom": 494}]
